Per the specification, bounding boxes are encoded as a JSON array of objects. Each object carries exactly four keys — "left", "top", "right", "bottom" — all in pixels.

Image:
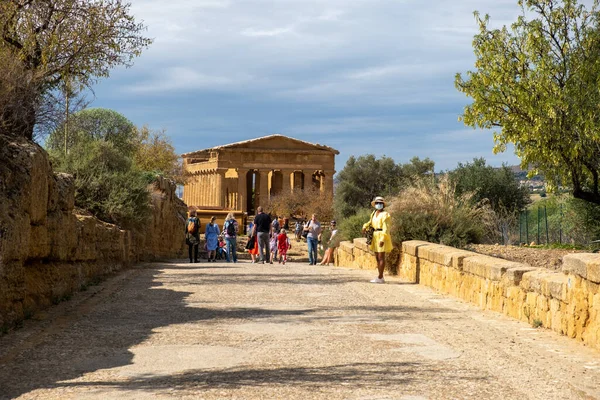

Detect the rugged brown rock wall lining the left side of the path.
[{"left": 0, "top": 133, "right": 187, "bottom": 328}]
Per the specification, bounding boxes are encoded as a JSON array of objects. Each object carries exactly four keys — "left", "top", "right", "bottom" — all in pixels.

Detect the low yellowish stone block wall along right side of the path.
[{"left": 336, "top": 239, "right": 600, "bottom": 349}]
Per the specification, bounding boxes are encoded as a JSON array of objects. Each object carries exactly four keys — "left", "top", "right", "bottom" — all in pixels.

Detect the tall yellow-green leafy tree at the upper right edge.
[{"left": 455, "top": 0, "right": 600, "bottom": 204}]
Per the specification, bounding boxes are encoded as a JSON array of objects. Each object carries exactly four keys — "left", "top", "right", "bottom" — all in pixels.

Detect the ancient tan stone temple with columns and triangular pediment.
[{"left": 183, "top": 135, "right": 339, "bottom": 220}]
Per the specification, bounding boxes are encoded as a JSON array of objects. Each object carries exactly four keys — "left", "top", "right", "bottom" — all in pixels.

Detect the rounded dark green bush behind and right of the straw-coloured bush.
[{"left": 450, "top": 158, "right": 531, "bottom": 213}]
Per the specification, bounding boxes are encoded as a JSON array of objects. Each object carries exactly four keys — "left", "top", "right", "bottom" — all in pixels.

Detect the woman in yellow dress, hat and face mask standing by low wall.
[{"left": 363, "top": 196, "right": 392, "bottom": 283}]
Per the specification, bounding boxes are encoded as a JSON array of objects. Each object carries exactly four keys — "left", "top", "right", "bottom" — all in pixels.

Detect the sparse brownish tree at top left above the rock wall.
[{"left": 0, "top": 0, "right": 152, "bottom": 139}]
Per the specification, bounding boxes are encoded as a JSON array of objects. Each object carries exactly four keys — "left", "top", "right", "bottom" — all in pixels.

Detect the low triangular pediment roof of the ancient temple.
[{"left": 181, "top": 134, "right": 340, "bottom": 158}]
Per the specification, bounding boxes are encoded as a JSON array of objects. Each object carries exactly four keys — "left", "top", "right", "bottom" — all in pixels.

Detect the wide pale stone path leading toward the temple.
[{"left": 0, "top": 261, "right": 600, "bottom": 400}]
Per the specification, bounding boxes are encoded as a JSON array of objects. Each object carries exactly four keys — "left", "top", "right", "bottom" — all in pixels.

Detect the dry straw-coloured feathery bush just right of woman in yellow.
[{"left": 388, "top": 176, "right": 494, "bottom": 247}]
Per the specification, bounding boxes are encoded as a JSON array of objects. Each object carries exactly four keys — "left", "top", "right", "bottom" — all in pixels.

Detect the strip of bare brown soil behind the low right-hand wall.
[{"left": 466, "top": 244, "right": 586, "bottom": 271}]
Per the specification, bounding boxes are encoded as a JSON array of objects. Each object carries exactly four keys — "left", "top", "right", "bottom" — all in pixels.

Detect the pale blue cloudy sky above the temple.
[{"left": 90, "top": 0, "right": 536, "bottom": 171}]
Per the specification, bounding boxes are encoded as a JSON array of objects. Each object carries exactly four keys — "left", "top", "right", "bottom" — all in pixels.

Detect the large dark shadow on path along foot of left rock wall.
[{"left": 0, "top": 264, "right": 313, "bottom": 399}]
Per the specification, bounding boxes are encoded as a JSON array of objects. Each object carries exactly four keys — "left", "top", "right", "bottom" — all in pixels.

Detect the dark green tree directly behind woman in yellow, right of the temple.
[{"left": 334, "top": 154, "right": 434, "bottom": 219}]
